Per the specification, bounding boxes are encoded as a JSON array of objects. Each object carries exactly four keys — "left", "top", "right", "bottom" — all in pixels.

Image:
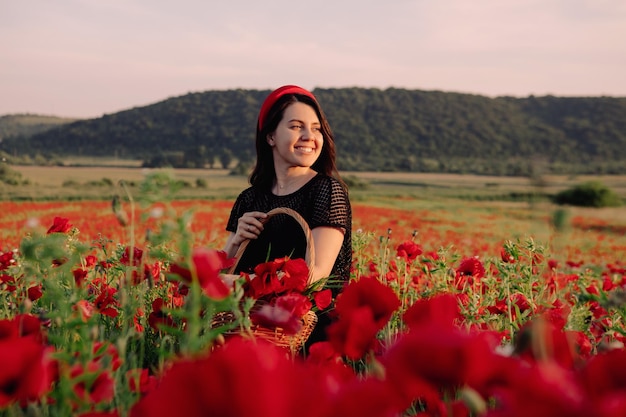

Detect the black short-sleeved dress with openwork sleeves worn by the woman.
[{"left": 226, "top": 174, "right": 352, "bottom": 345}]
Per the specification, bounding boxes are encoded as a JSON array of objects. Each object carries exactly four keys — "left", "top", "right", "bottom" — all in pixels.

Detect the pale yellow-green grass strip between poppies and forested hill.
[{"left": 0, "top": 160, "right": 626, "bottom": 201}]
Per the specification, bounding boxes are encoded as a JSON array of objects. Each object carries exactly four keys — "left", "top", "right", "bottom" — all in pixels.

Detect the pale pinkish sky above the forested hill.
[{"left": 0, "top": 0, "right": 626, "bottom": 118}]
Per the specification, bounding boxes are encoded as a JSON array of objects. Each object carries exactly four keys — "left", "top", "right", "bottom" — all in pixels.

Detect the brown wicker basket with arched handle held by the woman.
[{"left": 217, "top": 207, "right": 317, "bottom": 354}]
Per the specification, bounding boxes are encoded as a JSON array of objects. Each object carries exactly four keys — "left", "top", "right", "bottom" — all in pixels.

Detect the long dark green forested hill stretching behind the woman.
[{"left": 0, "top": 88, "right": 626, "bottom": 175}]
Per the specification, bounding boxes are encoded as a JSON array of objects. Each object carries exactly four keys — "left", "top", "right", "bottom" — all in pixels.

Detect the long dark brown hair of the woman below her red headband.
[{"left": 249, "top": 94, "right": 347, "bottom": 190}]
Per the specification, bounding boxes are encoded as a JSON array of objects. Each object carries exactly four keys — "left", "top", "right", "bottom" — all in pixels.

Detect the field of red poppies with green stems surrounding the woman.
[{"left": 0, "top": 171, "right": 626, "bottom": 417}]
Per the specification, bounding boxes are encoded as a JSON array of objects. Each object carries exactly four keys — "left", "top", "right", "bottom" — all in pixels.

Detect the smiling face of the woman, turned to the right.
[{"left": 267, "top": 102, "right": 324, "bottom": 168}]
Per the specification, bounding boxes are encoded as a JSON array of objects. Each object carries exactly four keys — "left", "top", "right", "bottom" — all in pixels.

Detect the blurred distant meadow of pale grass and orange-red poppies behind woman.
[{"left": 0, "top": 160, "right": 626, "bottom": 264}]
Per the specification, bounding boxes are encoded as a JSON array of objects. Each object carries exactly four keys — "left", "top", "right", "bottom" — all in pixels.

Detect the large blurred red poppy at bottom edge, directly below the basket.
[{"left": 130, "top": 337, "right": 326, "bottom": 417}]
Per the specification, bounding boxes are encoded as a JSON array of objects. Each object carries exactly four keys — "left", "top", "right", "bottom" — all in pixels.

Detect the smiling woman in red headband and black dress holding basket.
[{"left": 224, "top": 85, "right": 352, "bottom": 340}]
